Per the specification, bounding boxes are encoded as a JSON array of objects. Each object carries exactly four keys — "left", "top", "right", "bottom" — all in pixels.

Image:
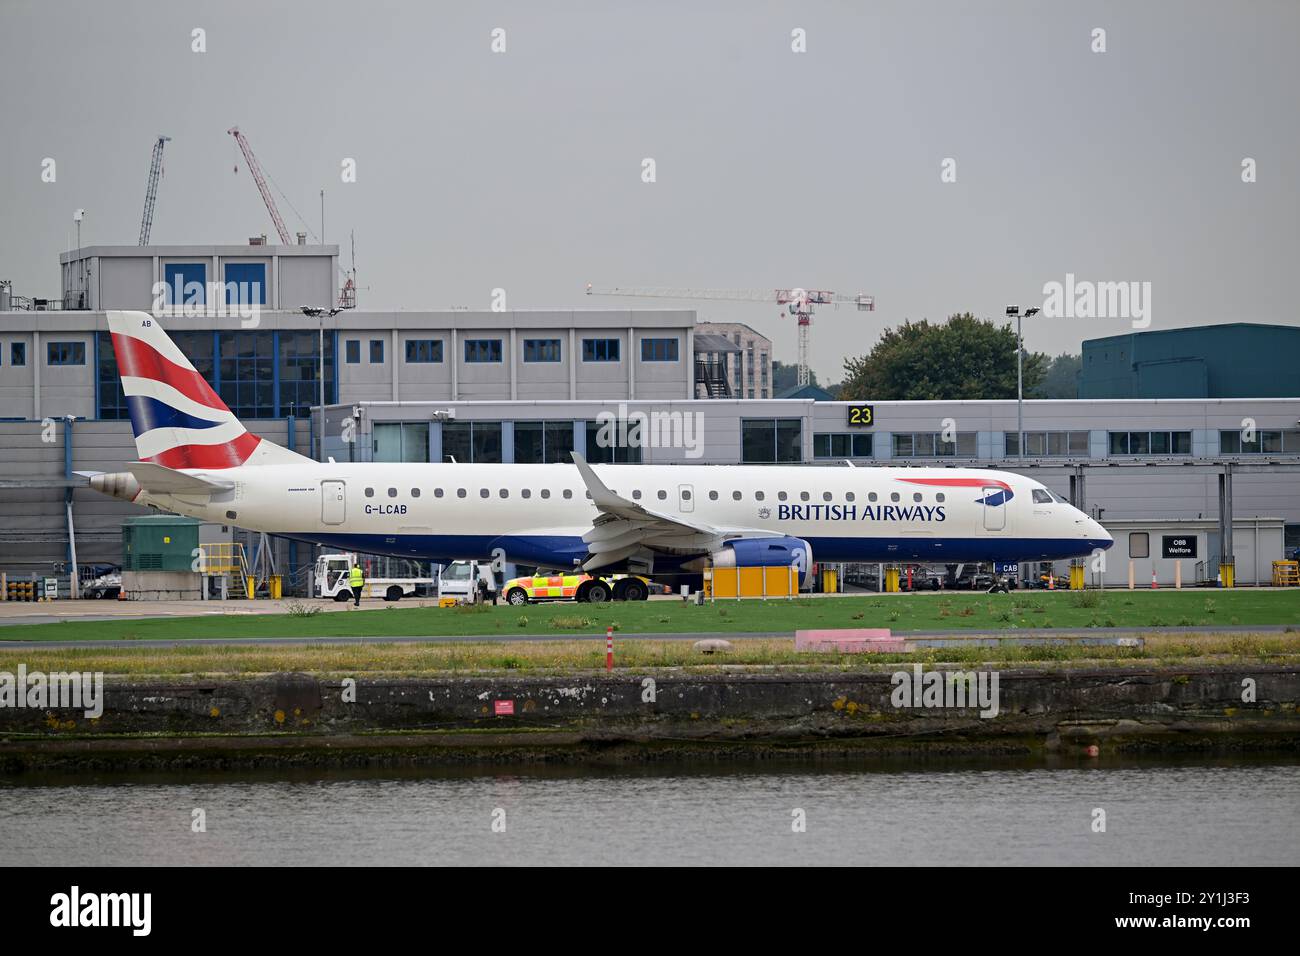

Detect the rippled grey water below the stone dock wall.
[{"left": 0, "top": 758, "right": 1300, "bottom": 866}]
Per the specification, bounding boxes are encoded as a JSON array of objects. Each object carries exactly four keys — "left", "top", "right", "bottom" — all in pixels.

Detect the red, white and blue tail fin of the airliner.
[{"left": 108, "top": 312, "right": 311, "bottom": 470}]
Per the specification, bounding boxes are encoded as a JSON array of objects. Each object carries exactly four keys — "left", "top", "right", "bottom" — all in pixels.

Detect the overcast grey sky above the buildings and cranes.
[{"left": 0, "top": 0, "right": 1300, "bottom": 380}]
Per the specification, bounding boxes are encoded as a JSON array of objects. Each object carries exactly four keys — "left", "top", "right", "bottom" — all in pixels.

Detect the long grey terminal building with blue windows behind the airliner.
[{"left": 0, "top": 246, "right": 1300, "bottom": 591}]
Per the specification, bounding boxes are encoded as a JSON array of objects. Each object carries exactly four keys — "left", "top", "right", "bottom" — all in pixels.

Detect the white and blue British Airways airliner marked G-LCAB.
[{"left": 90, "top": 312, "right": 1112, "bottom": 596}]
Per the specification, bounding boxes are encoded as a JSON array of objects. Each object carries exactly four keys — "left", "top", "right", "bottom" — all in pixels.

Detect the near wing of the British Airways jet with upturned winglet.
[{"left": 572, "top": 451, "right": 743, "bottom": 571}]
